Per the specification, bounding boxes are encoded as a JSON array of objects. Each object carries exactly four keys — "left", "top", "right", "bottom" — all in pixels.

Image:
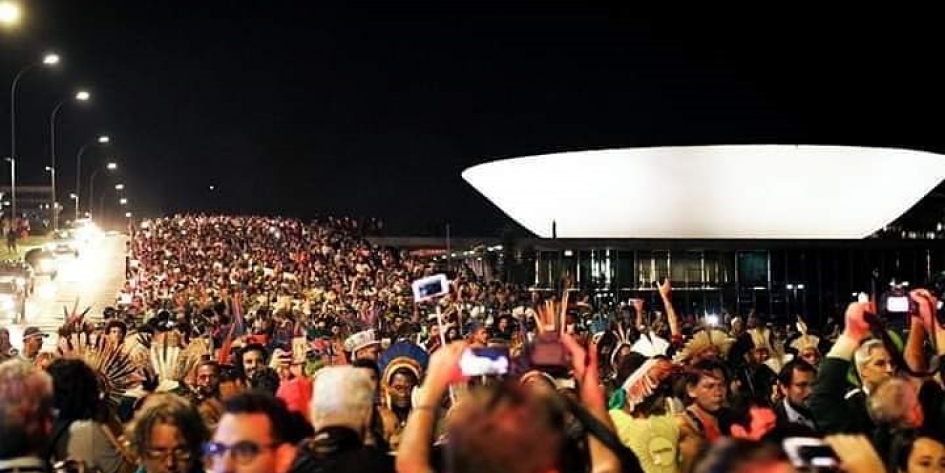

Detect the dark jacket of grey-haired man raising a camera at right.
[{"left": 808, "top": 357, "right": 876, "bottom": 435}]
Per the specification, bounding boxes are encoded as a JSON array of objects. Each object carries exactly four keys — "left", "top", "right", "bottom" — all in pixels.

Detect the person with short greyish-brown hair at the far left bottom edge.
[{"left": 0, "top": 359, "right": 53, "bottom": 473}]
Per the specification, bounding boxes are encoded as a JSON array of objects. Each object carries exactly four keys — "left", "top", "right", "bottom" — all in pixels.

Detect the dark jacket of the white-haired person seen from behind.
[{"left": 289, "top": 427, "right": 394, "bottom": 473}]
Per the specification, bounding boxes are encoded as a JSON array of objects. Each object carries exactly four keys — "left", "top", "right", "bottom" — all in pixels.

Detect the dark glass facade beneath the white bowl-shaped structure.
[{"left": 518, "top": 240, "right": 945, "bottom": 320}]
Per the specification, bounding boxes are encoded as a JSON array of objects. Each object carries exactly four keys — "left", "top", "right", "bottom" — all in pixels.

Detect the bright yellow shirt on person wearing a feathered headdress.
[{"left": 610, "top": 409, "right": 679, "bottom": 473}]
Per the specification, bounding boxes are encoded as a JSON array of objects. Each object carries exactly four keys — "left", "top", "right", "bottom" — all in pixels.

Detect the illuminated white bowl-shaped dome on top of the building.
[{"left": 463, "top": 145, "right": 945, "bottom": 239}]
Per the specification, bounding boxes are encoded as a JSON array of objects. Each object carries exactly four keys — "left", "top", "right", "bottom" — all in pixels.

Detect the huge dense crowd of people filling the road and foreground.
[{"left": 0, "top": 216, "right": 945, "bottom": 473}]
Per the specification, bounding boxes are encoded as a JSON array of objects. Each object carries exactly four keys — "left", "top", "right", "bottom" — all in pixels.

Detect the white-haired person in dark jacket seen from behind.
[{"left": 291, "top": 366, "right": 394, "bottom": 473}]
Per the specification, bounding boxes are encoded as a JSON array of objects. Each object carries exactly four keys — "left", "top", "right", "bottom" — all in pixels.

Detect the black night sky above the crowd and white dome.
[{"left": 0, "top": 0, "right": 945, "bottom": 236}]
